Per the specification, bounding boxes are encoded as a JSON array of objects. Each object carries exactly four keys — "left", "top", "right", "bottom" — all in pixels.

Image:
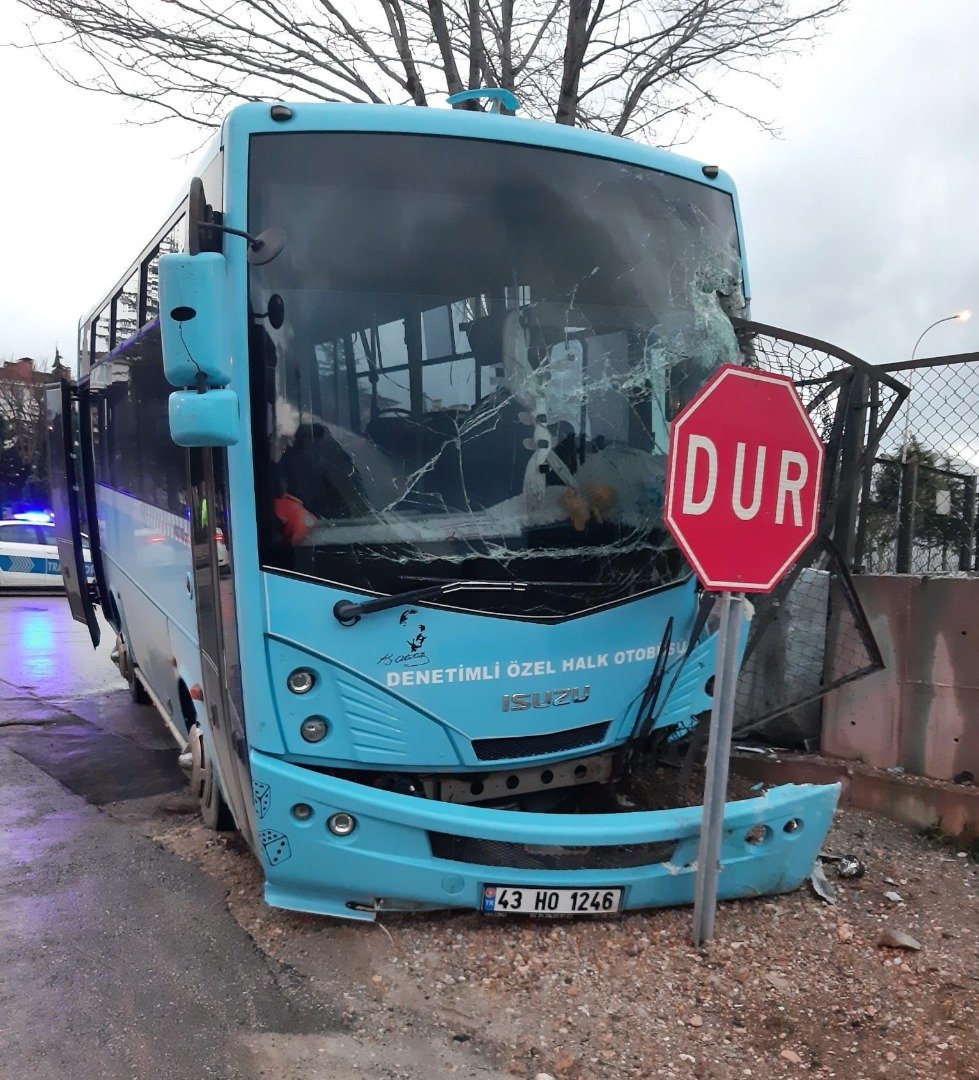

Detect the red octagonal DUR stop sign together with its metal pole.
[{"left": 663, "top": 365, "right": 824, "bottom": 946}]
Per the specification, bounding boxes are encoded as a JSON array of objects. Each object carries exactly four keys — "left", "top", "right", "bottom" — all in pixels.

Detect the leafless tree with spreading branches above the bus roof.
[{"left": 18, "top": 0, "right": 845, "bottom": 144}]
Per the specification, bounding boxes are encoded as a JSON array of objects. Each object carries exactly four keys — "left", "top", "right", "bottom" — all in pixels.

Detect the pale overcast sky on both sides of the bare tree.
[{"left": 0, "top": 0, "right": 979, "bottom": 362}]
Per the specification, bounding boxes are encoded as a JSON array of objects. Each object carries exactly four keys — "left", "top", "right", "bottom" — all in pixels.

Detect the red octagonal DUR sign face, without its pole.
[{"left": 665, "top": 364, "right": 824, "bottom": 593}]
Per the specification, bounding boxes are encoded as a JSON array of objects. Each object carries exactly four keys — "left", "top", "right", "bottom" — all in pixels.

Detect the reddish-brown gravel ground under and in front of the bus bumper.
[{"left": 141, "top": 799, "right": 979, "bottom": 1080}]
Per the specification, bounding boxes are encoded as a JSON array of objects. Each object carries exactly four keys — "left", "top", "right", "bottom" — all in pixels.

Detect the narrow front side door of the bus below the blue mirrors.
[{"left": 189, "top": 448, "right": 257, "bottom": 848}]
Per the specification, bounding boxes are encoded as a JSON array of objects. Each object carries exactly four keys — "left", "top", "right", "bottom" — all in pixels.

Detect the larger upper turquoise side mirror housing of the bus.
[{"left": 160, "top": 252, "right": 231, "bottom": 390}]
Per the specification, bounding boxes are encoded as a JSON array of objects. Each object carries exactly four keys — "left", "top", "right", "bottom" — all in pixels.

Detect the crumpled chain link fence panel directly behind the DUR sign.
[{"left": 717, "top": 322, "right": 907, "bottom": 745}]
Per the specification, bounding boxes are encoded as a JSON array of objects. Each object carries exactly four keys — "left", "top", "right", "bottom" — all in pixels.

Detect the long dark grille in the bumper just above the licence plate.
[{"left": 428, "top": 833, "right": 676, "bottom": 870}]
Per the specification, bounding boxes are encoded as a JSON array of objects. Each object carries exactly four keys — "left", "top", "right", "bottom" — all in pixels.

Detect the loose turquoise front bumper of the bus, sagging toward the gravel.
[{"left": 252, "top": 751, "right": 840, "bottom": 919}]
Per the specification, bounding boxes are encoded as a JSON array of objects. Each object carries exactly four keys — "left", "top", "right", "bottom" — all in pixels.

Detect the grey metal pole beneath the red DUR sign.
[{"left": 694, "top": 591, "right": 745, "bottom": 948}]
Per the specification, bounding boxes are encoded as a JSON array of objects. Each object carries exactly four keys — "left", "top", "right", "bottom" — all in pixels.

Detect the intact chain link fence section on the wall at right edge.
[{"left": 853, "top": 353, "right": 979, "bottom": 575}]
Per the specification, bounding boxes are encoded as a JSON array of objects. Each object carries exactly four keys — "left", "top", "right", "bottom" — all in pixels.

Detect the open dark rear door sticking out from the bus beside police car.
[{"left": 45, "top": 379, "right": 102, "bottom": 648}]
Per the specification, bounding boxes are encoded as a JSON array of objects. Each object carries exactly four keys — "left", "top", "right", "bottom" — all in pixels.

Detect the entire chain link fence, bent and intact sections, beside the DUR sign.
[{"left": 665, "top": 332, "right": 979, "bottom": 747}]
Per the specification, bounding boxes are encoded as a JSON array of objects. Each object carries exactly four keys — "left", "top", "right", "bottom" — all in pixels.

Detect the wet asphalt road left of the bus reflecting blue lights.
[{"left": 0, "top": 596, "right": 338, "bottom": 1080}]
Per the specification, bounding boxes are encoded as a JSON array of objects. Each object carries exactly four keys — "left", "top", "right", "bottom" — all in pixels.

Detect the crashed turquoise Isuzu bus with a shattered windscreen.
[{"left": 49, "top": 92, "right": 837, "bottom": 919}]
